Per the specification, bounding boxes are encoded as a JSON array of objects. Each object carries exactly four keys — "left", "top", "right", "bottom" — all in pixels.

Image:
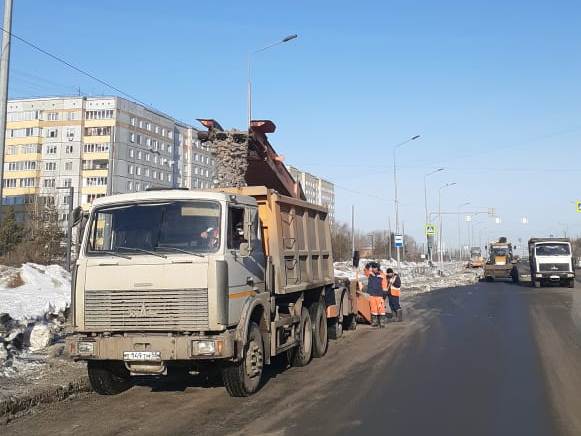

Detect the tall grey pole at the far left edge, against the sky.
[{"left": 0, "top": 0, "right": 12, "bottom": 217}]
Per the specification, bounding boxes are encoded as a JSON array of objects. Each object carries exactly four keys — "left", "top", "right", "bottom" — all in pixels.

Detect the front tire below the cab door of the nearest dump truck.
[{"left": 222, "top": 322, "right": 264, "bottom": 397}]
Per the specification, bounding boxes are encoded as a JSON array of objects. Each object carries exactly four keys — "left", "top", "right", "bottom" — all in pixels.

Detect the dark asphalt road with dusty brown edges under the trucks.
[{"left": 0, "top": 283, "right": 581, "bottom": 436}]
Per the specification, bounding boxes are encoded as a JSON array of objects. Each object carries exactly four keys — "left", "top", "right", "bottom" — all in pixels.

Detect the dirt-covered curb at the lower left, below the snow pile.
[{"left": 0, "top": 376, "right": 91, "bottom": 419}]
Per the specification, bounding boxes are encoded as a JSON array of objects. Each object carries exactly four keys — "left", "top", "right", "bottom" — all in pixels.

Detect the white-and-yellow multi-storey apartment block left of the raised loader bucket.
[{"left": 3, "top": 97, "right": 212, "bottom": 228}]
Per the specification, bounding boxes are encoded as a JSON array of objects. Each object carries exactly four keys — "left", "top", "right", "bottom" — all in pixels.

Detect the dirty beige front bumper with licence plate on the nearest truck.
[{"left": 66, "top": 330, "right": 236, "bottom": 362}]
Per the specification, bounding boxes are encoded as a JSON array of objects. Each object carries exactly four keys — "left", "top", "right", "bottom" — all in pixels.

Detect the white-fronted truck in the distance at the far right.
[{"left": 529, "top": 238, "right": 575, "bottom": 288}]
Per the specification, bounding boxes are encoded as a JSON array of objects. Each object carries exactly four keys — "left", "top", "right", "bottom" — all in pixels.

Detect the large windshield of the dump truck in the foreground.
[{"left": 87, "top": 201, "right": 221, "bottom": 256}]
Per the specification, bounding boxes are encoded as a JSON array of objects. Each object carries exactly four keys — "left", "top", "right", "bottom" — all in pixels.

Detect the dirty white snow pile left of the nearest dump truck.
[{"left": 0, "top": 263, "right": 71, "bottom": 376}]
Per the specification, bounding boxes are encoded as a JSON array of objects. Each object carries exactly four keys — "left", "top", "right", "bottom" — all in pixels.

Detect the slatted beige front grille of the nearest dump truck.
[{"left": 85, "top": 289, "right": 208, "bottom": 331}]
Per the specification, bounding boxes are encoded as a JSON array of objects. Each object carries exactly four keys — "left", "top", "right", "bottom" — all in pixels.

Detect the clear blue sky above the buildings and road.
[{"left": 4, "top": 0, "right": 581, "bottom": 244}]
